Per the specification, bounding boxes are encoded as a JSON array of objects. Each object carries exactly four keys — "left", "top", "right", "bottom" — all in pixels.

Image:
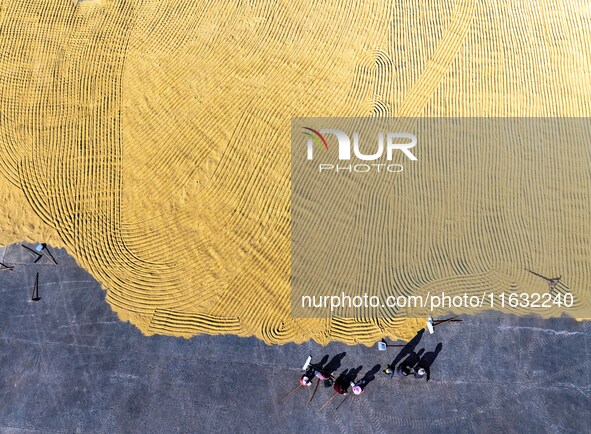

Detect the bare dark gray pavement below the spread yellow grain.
[{"left": 0, "top": 245, "right": 591, "bottom": 433}]
